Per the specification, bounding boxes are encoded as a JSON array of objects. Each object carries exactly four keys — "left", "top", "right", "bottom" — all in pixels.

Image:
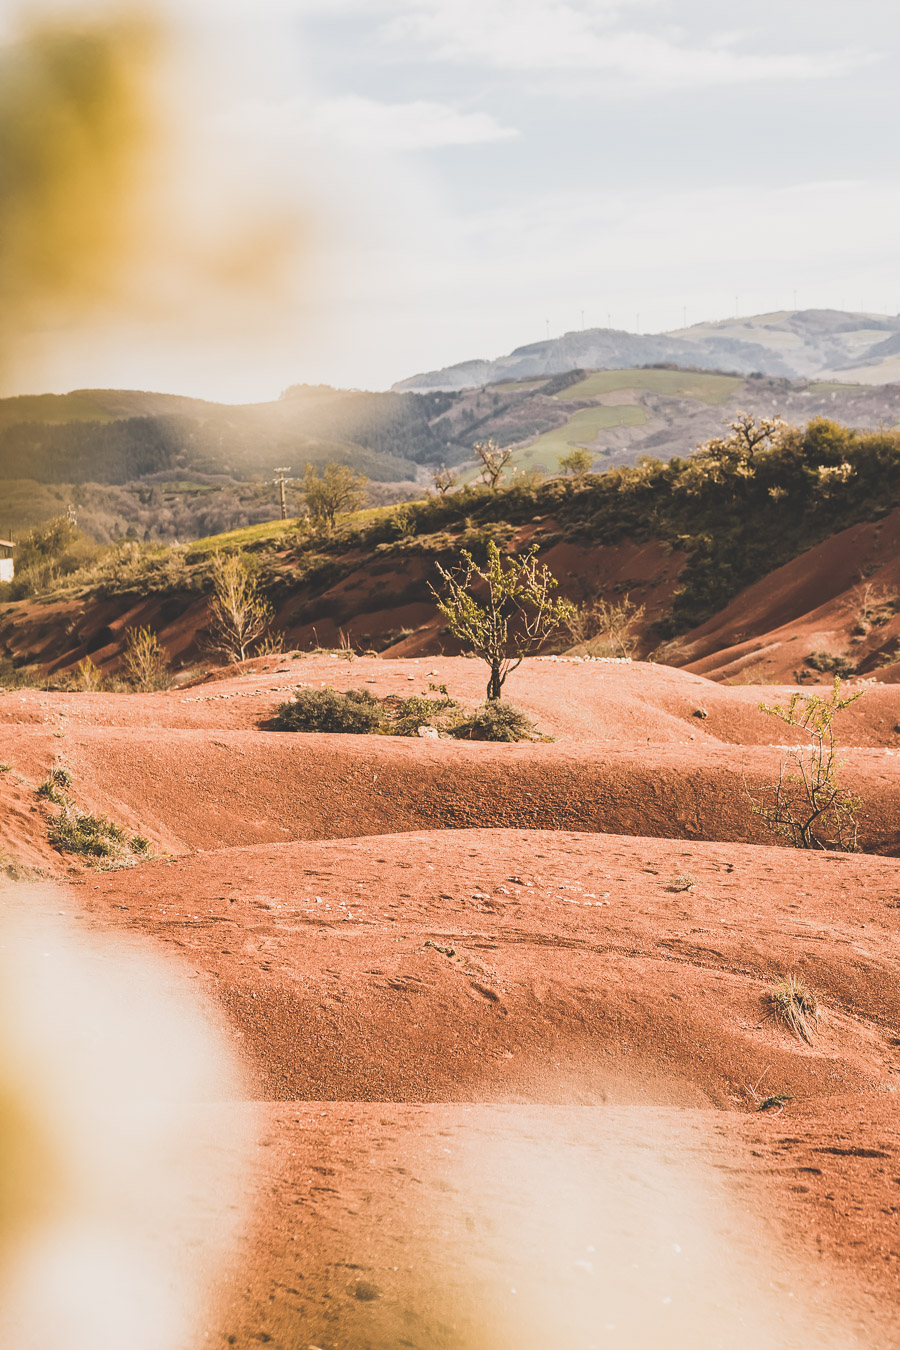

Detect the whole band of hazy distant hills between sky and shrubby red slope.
[{"left": 0, "top": 311, "right": 900, "bottom": 543}]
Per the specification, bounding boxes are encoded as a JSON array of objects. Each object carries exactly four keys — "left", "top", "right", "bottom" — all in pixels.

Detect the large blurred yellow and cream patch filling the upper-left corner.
[{"left": 0, "top": 0, "right": 316, "bottom": 394}]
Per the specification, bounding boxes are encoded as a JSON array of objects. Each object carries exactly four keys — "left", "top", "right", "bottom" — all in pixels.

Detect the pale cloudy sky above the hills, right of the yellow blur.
[{"left": 7, "top": 0, "right": 900, "bottom": 400}]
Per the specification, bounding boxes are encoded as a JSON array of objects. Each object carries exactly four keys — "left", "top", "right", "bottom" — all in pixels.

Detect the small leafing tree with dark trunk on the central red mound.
[{"left": 432, "top": 541, "right": 572, "bottom": 702}]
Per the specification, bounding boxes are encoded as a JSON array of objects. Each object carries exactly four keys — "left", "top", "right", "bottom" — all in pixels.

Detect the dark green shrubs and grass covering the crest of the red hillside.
[{"left": 0, "top": 414, "right": 900, "bottom": 639}]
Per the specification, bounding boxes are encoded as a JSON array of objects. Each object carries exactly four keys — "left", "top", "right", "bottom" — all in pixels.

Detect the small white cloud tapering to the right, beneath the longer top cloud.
[{"left": 310, "top": 95, "right": 518, "bottom": 150}]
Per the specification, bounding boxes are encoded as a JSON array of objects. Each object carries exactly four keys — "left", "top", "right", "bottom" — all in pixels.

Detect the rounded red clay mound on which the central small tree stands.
[{"left": 0, "top": 657, "right": 900, "bottom": 855}]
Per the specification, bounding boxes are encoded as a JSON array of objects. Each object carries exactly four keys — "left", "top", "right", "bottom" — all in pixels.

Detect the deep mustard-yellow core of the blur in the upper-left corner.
[{"left": 0, "top": 12, "right": 162, "bottom": 365}]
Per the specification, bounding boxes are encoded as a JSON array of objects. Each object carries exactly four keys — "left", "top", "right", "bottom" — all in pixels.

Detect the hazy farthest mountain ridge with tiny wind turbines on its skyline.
[{"left": 393, "top": 309, "right": 900, "bottom": 393}]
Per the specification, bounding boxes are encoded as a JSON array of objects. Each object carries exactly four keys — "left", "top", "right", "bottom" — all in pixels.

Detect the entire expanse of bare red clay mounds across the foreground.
[{"left": 0, "top": 657, "right": 900, "bottom": 1350}]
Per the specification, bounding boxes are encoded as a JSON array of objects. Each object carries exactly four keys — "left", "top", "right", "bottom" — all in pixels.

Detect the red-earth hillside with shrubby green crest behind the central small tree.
[{"left": 0, "top": 419, "right": 900, "bottom": 683}]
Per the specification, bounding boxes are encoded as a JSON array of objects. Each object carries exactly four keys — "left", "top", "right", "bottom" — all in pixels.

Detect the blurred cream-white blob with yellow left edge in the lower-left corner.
[{"left": 0, "top": 888, "right": 251, "bottom": 1350}]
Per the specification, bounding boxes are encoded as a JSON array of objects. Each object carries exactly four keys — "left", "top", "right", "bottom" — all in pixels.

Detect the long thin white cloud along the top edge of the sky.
[{"left": 376, "top": 0, "right": 874, "bottom": 89}]
